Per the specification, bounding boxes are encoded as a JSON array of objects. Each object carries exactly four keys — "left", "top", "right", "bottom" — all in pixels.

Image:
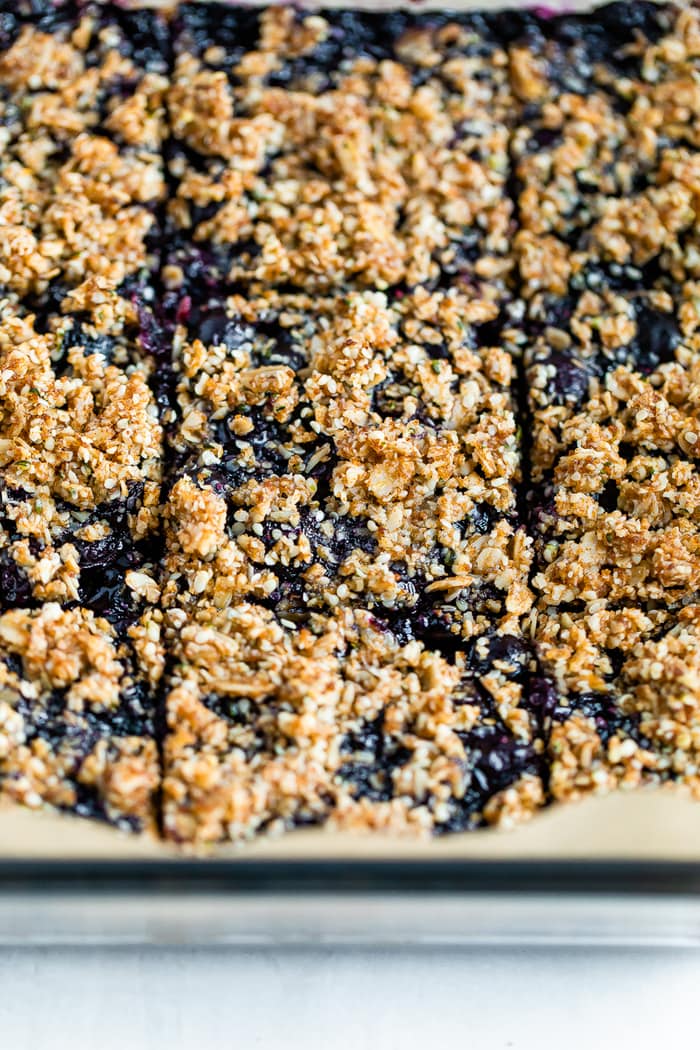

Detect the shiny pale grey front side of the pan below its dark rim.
[{"left": 0, "top": 885, "right": 700, "bottom": 951}]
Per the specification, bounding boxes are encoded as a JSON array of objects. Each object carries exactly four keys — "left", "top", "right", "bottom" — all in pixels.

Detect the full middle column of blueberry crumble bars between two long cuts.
[{"left": 157, "top": 5, "right": 545, "bottom": 841}]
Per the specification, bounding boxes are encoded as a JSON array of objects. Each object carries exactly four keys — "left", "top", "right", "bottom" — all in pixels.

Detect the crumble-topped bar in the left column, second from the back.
[{"left": 0, "top": 296, "right": 163, "bottom": 631}]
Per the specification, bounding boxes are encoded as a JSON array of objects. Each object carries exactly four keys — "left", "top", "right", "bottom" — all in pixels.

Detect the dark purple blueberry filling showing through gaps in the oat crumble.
[{"left": 0, "top": 0, "right": 696, "bottom": 831}]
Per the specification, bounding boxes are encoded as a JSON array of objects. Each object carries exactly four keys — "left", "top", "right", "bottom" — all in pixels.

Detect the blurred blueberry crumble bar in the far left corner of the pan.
[{"left": 0, "top": 3, "right": 169, "bottom": 312}]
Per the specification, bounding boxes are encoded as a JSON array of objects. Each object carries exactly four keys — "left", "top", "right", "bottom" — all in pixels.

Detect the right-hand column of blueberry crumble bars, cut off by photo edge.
[{"left": 511, "top": 4, "right": 700, "bottom": 799}]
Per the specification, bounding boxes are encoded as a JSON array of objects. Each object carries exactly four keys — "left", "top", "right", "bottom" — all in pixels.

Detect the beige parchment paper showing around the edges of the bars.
[{"left": 0, "top": 0, "right": 700, "bottom": 861}]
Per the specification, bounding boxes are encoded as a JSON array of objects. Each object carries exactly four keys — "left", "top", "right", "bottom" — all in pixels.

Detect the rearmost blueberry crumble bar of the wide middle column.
[{"left": 164, "top": 4, "right": 512, "bottom": 294}]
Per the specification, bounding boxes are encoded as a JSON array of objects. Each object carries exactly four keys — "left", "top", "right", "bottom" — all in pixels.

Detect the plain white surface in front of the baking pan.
[{"left": 0, "top": 948, "right": 700, "bottom": 1050}]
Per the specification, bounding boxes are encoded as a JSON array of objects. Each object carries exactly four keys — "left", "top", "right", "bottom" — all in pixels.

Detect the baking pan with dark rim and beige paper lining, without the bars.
[{"left": 0, "top": 0, "right": 700, "bottom": 945}]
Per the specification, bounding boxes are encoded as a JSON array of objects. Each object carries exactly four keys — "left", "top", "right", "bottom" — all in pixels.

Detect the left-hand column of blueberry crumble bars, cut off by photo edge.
[{"left": 0, "top": 0, "right": 168, "bottom": 831}]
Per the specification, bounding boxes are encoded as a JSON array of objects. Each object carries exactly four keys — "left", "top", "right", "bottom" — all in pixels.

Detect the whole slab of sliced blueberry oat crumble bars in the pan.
[{"left": 0, "top": 0, "right": 700, "bottom": 844}]
